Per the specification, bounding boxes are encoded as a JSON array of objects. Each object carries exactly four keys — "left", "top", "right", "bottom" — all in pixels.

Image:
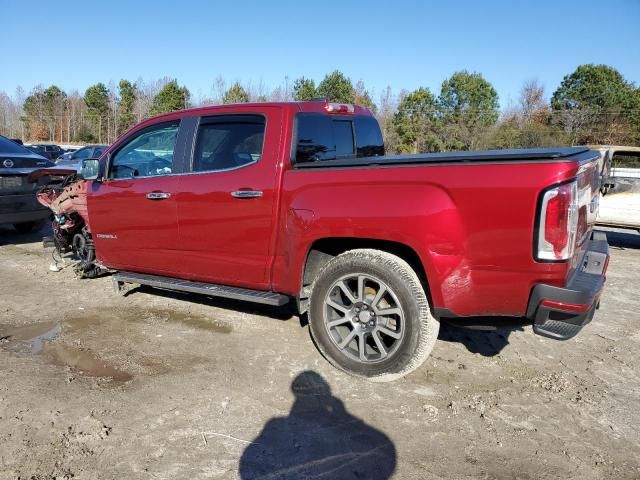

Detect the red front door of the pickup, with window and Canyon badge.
[{"left": 88, "top": 120, "right": 190, "bottom": 275}]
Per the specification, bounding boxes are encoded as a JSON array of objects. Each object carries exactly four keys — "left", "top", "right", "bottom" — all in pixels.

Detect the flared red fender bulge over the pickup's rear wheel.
[{"left": 272, "top": 183, "right": 472, "bottom": 307}]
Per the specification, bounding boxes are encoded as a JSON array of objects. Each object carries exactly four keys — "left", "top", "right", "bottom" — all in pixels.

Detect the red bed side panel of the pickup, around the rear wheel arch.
[{"left": 273, "top": 162, "right": 578, "bottom": 315}]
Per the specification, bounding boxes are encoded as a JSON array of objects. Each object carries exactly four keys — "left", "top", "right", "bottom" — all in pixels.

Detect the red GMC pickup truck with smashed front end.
[{"left": 36, "top": 101, "right": 609, "bottom": 380}]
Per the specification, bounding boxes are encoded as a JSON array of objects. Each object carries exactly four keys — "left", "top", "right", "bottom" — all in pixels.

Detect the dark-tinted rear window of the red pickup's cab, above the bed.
[{"left": 294, "top": 113, "right": 384, "bottom": 164}]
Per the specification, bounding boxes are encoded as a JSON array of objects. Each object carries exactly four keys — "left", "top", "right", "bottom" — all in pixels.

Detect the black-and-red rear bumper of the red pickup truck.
[{"left": 527, "top": 232, "right": 609, "bottom": 340}]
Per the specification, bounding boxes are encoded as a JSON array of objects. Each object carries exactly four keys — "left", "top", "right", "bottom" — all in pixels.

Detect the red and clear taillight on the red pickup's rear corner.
[{"left": 538, "top": 181, "right": 578, "bottom": 260}]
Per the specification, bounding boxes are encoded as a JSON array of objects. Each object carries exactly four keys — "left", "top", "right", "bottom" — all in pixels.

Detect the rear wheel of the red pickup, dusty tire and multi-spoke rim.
[{"left": 309, "top": 249, "right": 440, "bottom": 382}]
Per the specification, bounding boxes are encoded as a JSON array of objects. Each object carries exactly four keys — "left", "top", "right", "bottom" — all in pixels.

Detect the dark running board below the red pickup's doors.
[{"left": 111, "top": 272, "right": 289, "bottom": 307}]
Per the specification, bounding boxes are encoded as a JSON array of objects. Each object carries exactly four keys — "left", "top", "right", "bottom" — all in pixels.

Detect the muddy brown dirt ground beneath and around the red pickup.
[{"left": 0, "top": 227, "right": 640, "bottom": 480}]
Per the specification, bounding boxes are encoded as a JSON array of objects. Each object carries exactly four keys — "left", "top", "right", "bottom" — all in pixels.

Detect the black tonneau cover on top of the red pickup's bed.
[{"left": 296, "top": 147, "right": 597, "bottom": 168}]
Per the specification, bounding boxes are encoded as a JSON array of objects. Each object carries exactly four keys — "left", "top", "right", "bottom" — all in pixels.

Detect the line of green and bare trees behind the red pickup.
[{"left": 0, "top": 64, "right": 640, "bottom": 153}]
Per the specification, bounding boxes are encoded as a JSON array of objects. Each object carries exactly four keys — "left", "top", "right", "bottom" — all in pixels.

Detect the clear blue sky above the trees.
[{"left": 0, "top": 0, "right": 640, "bottom": 107}]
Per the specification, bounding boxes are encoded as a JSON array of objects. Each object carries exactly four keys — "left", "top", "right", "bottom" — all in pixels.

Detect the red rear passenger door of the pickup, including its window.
[{"left": 178, "top": 107, "right": 283, "bottom": 288}]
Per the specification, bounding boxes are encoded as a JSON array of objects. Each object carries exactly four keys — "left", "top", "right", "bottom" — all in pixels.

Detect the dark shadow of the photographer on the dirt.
[{"left": 239, "top": 371, "right": 396, "bottom": 480}]
